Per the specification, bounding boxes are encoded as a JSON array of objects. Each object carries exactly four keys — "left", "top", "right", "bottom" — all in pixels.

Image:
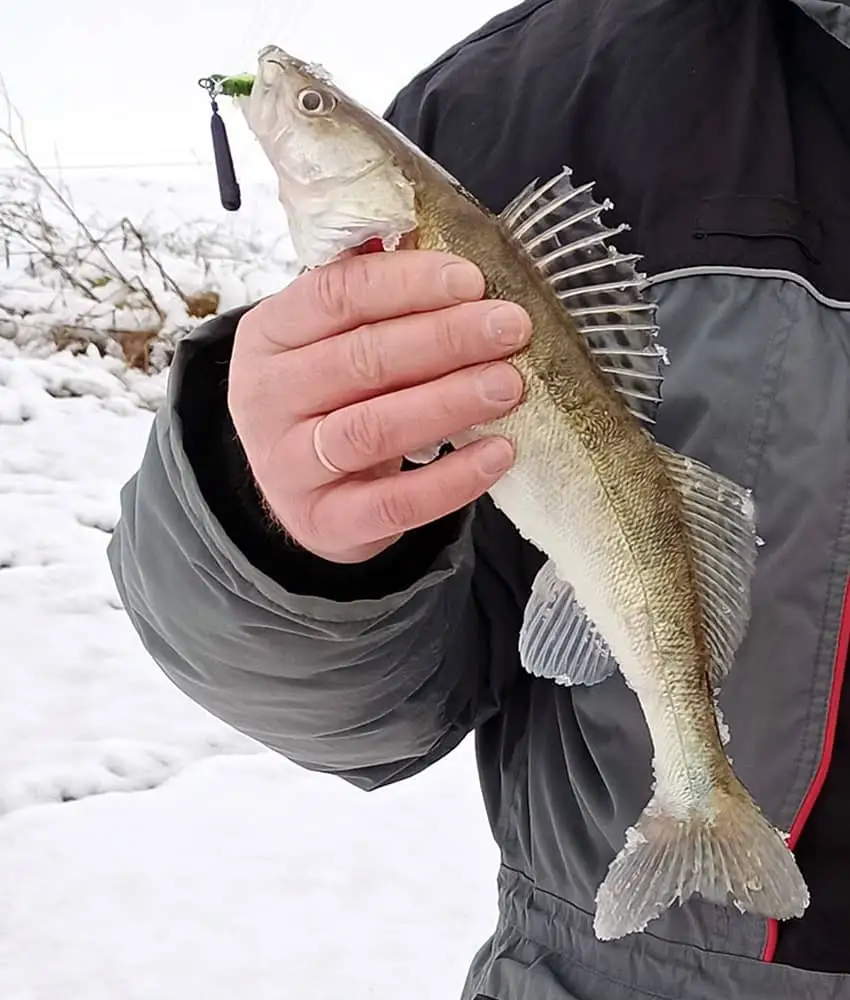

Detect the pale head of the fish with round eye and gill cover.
[{"left": 239, "top": 46, "right": 416, "bottom": 267}]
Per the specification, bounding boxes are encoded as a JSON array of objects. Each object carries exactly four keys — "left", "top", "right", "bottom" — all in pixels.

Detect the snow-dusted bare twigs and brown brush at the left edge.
[{"left": 0, "top": 77, "right": 238, "bottom": 371}]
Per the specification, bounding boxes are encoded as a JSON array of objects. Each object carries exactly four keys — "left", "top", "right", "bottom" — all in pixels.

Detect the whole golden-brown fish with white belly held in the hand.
[{"left": 222, "top": 45, "right": 809, "bottom": 940}]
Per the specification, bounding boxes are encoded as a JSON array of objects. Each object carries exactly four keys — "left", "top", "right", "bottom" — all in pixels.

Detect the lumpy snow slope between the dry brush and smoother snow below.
[{"left": 0, "top": 355, "right": 253, "bottom": 820}]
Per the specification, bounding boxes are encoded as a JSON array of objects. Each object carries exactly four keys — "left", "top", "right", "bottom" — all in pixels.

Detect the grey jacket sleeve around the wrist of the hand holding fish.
[{"left": 109, "top": 304, "right": 518, "bottom": 788}]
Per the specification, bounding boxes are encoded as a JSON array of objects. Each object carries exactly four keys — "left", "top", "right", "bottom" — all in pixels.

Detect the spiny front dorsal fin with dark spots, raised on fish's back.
[{"left": 500, "top": 167, "right": 667, "bottom": 424}]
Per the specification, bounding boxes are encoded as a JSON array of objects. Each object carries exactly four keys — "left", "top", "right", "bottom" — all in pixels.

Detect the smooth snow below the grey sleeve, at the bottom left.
[{"left": 0, "top": 754, "right": 495, "bottom": 1000}]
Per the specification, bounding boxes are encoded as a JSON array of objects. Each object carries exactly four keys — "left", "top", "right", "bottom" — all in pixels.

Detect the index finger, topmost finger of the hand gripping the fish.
[{"left": 239, "top": 250, "right": 484, "bottom": 353}]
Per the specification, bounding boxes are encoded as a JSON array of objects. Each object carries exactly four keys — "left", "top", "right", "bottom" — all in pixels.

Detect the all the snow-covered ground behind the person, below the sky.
[{"left": 0, "top": 173, "right": 497, "bottom": 1000}]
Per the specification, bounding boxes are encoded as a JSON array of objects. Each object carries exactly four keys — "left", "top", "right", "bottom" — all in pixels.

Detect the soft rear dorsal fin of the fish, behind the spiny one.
[{"left": 656, "top": 445, "right": 758, "bottom": 691}]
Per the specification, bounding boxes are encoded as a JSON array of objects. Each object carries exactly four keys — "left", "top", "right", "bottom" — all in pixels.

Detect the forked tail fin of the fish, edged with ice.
[{"left": 593, "top": 788, "right": 809, "bottom": 941}]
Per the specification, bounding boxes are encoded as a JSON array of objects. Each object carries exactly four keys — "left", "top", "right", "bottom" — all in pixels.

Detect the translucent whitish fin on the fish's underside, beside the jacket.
[{"left": 519, "top": 559, "right": 617, "bottom": 685}]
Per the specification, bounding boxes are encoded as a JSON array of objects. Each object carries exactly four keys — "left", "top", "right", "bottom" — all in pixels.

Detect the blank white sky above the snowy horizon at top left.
[{"left": 0, "top": 0, "right": 511, "bottom": 177}]
